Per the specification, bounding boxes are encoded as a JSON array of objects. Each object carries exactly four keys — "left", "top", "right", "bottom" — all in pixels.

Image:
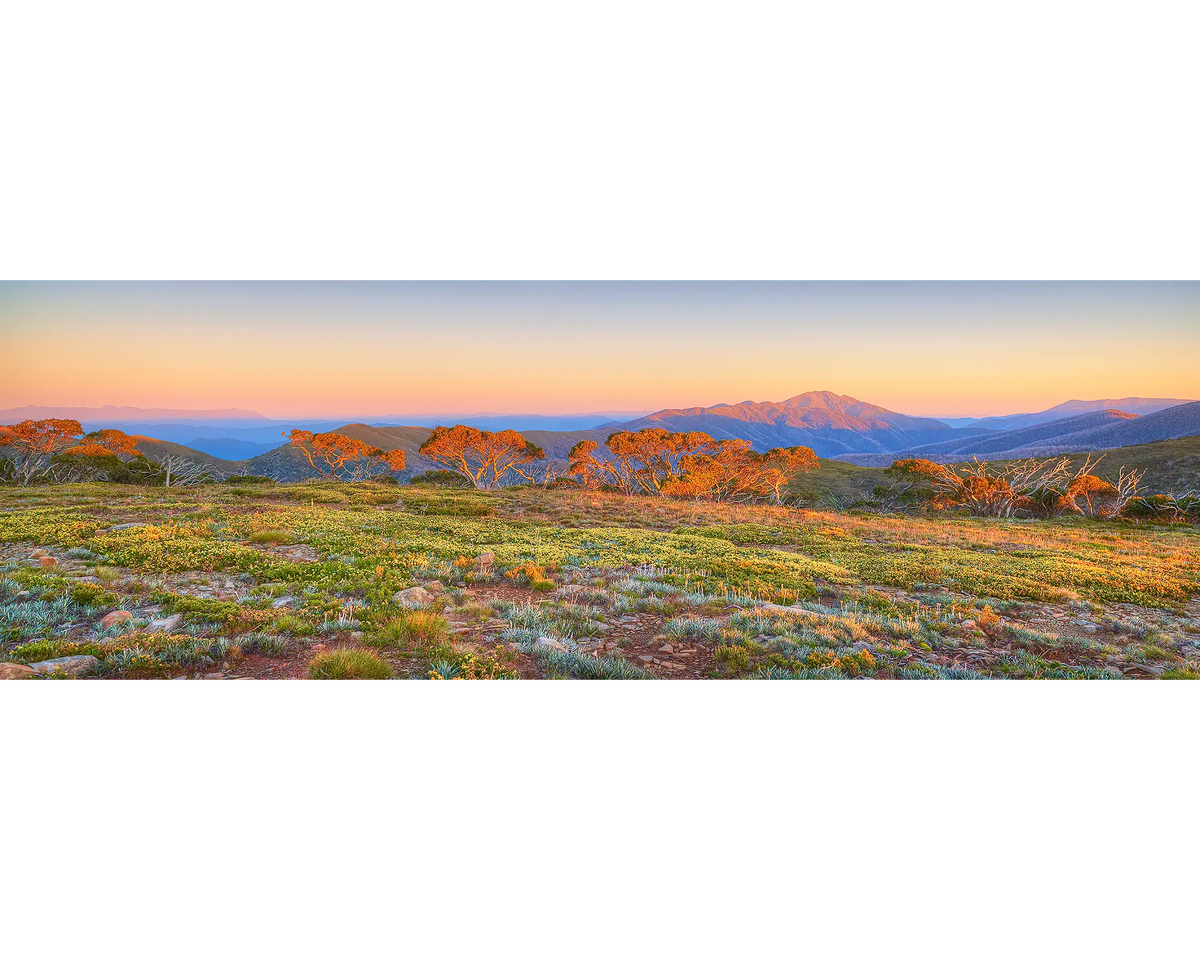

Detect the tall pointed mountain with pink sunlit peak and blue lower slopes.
[{"left": 605, "top": 391, "right": 969, "bottom": 457}]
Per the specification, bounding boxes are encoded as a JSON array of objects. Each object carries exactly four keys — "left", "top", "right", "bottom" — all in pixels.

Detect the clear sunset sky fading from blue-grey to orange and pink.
[{"left": 0, "top": 278, "right": 1200, "bottom": 419}]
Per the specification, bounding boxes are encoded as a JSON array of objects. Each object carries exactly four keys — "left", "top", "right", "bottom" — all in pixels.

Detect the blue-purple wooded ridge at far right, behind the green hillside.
[{"left": 838, "top": 402, "right": 1200, "bottom": 467}]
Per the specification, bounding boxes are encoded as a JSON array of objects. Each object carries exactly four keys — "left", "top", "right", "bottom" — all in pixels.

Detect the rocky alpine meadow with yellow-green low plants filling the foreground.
[{"left": 0, "top": 484, "right": 1200, "bottom": 682}]
